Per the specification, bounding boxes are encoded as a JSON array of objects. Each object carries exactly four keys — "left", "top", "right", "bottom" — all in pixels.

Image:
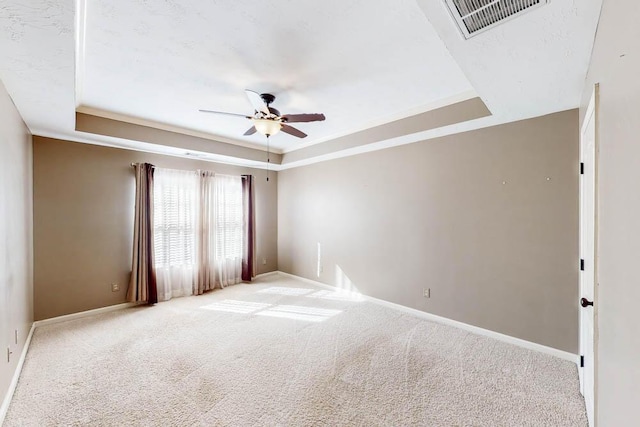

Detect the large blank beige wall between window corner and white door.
[{"left": 278, "top": 110, "right": 578, "bottom": 353}]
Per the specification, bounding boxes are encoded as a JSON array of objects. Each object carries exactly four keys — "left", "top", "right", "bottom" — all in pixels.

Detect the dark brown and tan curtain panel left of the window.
[{"left": 127, "top": 163, "right": 158, "bottom": 304}]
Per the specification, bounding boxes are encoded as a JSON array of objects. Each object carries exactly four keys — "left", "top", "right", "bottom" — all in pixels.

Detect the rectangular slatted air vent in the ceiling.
[{"left": 445, "top": 0, "right": 549, "bottom": 39}]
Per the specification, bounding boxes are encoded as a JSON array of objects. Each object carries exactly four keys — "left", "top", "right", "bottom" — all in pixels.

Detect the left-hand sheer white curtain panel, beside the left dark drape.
[{"left": 153, "top": 168, "right": 199, "bottom": 301}]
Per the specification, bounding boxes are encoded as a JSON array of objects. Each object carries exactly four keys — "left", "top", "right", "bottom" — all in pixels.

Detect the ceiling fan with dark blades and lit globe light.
[{"left": 199, "top": 89, "right": 325, "bottom": 138}]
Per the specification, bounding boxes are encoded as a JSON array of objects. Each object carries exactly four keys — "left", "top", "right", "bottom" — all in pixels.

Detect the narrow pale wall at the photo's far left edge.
[{"left": 0, "top": 82, "right": 33, "bottom": 414}]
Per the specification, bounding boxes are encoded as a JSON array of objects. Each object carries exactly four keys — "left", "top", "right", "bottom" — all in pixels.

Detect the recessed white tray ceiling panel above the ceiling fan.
[{"left": 77, "top": 0, "right": 472, "bottom": 150}]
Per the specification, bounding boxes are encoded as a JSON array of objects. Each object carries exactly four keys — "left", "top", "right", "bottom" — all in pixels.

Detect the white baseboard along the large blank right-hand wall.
[{"left": 278, "top": 271, "right": 580, "bottom": 366}]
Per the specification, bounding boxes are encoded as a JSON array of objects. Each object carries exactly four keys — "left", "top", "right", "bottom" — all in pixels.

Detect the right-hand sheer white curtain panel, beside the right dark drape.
[{"left": 213, "top": 174, "right": 243, "bottom": 287}]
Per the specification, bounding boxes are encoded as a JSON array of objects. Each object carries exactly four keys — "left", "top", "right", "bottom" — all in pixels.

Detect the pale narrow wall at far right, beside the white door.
[{"left": 580, "top": 0, "right": 640, "bottom": 426}]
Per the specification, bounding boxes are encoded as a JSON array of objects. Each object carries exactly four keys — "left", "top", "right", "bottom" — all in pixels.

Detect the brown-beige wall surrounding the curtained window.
[{"left": 33, "top": 137, "right": 277, "bottom": 320}]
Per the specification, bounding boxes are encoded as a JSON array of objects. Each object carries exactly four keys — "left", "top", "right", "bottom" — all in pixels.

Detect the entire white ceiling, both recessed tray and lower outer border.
[{"left": 0, "top": 0, "right": 602, "bottom": 167}]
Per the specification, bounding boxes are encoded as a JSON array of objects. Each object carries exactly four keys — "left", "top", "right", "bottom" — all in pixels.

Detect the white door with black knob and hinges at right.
[{"left": 578, "top": 86, "right": 598, "bottom": 426}]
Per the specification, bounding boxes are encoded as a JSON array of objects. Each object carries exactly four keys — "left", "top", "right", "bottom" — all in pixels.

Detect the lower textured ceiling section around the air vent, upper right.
[{"left": 416, "top": 0, "right": 602, "bottom": 122}]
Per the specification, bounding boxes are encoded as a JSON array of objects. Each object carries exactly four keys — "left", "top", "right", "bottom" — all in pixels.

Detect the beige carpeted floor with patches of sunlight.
[{"left": 5, "top": 275, "right": 587, "bottom": 427}]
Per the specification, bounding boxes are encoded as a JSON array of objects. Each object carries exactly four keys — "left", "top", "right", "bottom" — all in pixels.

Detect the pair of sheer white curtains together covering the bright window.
[{"left": 154, "top": 168, "right": 244, "bottom": 301}]
